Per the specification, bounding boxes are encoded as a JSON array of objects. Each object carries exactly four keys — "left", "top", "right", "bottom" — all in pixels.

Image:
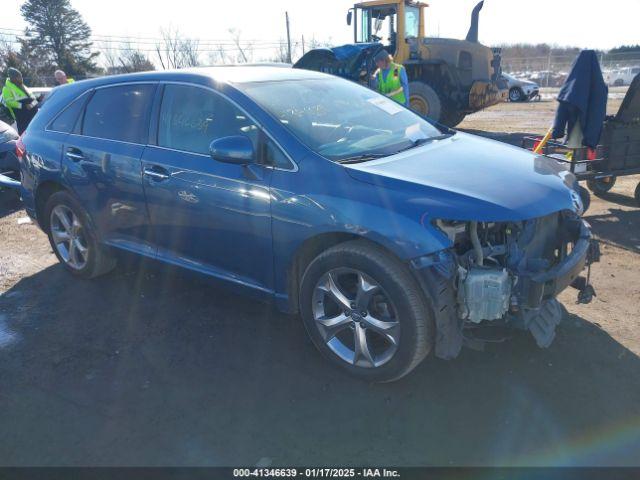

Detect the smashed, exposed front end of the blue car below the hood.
[{"left": 412, "top": 211, "right": 599, "bottom": 358}]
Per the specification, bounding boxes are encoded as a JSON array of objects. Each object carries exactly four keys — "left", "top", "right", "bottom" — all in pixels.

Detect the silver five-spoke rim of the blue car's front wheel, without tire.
[{"left": 312, "top": 268, "right": 400, "bottom": 368}]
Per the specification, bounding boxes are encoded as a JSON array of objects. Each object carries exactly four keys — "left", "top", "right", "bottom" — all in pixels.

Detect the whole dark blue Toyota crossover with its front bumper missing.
[{"left": 10, "top": 67, "right": 595, "bottom": 381}]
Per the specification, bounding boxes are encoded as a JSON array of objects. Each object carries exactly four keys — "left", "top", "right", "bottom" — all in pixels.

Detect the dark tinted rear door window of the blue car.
[{"left": 82, "top": 84, "right": 156, "bottom": 144}]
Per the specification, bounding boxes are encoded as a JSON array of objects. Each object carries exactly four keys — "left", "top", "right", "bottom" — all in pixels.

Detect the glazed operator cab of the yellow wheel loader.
[{"left": 347, "top": 0, "right": 427, "bottom": 63}]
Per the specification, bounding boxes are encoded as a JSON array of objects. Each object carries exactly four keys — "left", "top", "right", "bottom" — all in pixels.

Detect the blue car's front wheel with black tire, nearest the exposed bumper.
[{"left": 299, "top": 240, "right": 434, "bottom": 382}]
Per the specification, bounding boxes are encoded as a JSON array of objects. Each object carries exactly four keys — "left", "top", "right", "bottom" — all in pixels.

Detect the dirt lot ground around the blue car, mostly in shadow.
[{"left": 0, "top": 97, "right": 640, "bottom": 466}]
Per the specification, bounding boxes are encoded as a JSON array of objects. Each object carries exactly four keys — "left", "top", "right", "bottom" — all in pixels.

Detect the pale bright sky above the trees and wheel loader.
[{"left": 0, "top": 0, "right": 640, "bottom": 55}]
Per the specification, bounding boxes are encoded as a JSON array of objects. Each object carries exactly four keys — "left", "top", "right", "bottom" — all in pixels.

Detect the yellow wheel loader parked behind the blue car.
[{"left": 294, "top": 0, "right": 508, "bottom": 127}]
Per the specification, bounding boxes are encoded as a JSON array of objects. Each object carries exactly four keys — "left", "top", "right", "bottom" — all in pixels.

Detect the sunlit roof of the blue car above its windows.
[{"left": 69, "top": 64, "right": 335, "bottom": 88}]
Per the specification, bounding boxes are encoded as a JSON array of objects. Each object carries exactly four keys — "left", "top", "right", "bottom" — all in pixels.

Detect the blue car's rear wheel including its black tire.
[{"left": 44, "top": 190, "right": 116, "bottom": 278}]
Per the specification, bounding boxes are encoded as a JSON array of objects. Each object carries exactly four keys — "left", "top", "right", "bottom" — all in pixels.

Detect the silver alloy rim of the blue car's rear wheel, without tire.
[{"left": 50, "top": 205, "right": 89, "bottom": 270}]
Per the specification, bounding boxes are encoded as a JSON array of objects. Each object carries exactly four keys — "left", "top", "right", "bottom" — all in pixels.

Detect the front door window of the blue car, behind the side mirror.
[{"left": 158, "top": 85, "right": 258, "bottom": 154}]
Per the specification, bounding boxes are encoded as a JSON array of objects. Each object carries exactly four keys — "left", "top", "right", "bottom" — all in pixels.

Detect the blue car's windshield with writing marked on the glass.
[{"left": 241, "top": 78, "right": 442, "bottom": 161}]
